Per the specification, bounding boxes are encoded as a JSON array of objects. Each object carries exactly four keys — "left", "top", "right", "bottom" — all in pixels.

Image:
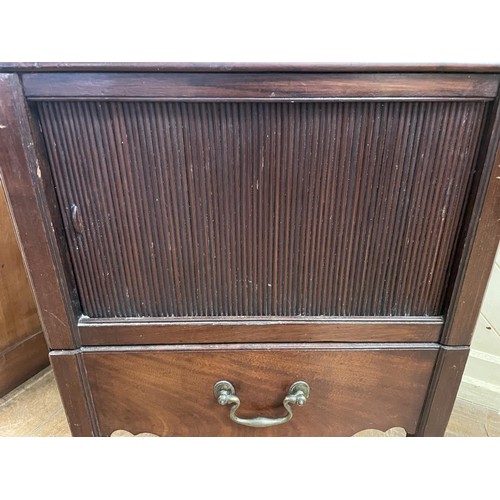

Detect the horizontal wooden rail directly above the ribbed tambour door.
[{"left": 23, "top": 73, "right": 499, "bottom": 101}]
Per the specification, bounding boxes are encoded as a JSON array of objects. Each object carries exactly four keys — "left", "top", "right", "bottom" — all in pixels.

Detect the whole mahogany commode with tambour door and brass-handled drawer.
[{"left": 0, "top": 63, "right": 500, "bottom": 436}]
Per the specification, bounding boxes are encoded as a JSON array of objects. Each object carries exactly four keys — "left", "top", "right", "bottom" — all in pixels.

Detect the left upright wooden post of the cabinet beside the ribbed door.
[{"left": 0, "top": 74, "right": 78, "bottom": 348}]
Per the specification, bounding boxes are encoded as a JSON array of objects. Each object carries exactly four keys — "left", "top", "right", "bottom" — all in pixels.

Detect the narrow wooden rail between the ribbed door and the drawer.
[{"left": 78, "top": 318, "right": 443, "bottom": 346}]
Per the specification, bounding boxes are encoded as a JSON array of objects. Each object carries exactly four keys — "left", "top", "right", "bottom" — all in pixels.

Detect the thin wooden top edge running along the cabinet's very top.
[{"left": 0, "top": 61, "right": 500, "bottom": 73}]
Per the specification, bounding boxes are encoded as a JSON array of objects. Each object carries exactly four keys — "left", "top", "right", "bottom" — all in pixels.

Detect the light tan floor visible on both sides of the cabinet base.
[{"left": 0, "top": 368, "right": 500, "bottom": 437}]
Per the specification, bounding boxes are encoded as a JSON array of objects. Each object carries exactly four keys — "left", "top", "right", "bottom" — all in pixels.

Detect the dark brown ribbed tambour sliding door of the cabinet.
[{"left": 38, "top": 101, "right": 486, "bottom": 317}]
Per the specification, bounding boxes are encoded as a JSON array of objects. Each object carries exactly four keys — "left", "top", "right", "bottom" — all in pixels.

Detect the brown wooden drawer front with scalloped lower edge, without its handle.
[{"left": 68, "top": 344, "right": 438, "bottom": 436}]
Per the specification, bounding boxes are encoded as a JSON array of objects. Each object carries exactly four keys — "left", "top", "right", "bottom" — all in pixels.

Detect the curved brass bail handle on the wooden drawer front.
[{"left": 214, "top": 380, "right": 310, "bottom": 427}]
